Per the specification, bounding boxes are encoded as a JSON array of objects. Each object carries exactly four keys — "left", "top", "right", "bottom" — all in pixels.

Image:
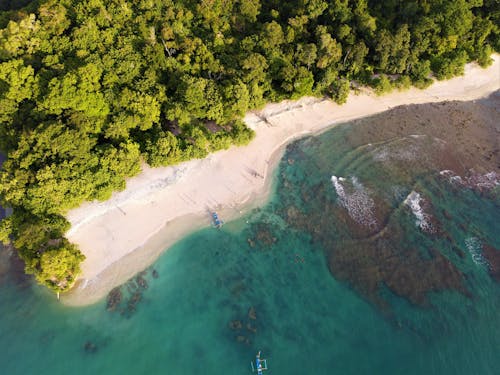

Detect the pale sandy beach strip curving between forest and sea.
[{"left": 62, "top": 55, "right": 500, "bottom": 305}]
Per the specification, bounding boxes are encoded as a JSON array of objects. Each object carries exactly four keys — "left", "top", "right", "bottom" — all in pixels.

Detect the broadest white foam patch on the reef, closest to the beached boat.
[{"left": 331, "top": 176, "right": 377, "bottom": 227}]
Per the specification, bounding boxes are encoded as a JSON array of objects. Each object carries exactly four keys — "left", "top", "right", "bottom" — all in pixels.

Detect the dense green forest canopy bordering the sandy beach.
[{"left": 0, "top": 0, "right": 500, "bottom": 291}]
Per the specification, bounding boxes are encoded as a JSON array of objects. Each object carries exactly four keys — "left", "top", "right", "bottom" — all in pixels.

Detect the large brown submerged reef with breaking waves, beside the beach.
[{"left": 274, "top": 93, "right": 500, "bottom": 311}]
